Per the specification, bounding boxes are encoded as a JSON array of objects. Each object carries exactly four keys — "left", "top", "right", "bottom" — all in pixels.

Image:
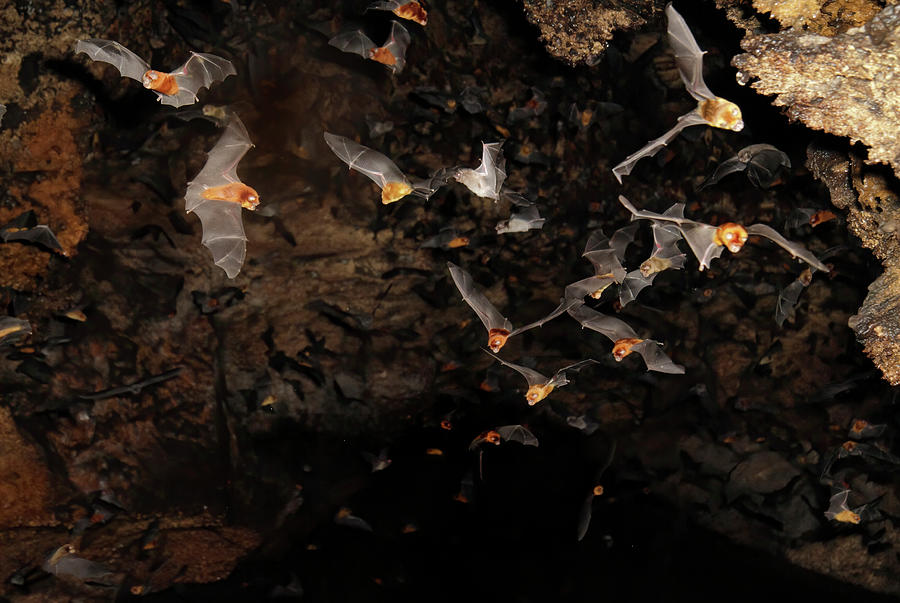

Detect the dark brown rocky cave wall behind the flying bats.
[{"left": 0, "top": 2, "right": 900, "bottom": 601}]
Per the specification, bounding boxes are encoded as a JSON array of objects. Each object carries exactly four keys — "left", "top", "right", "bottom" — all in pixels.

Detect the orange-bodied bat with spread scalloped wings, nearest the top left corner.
[{"left": 75, "top": 39, "right": 237, "bottom": 107}]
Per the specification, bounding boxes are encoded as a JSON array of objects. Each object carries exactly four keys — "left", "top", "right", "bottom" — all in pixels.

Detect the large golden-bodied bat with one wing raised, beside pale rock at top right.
[{"left": 613, "top": 3, "right": 744, "bottom": 184}]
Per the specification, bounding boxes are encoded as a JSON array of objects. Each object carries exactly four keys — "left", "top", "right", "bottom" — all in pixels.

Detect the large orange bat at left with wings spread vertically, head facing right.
[{"left": 184, "top": 114, "right": 259, "bottom": 278}]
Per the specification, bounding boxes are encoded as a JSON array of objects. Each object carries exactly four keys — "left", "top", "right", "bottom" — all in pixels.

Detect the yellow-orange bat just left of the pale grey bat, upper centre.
[{"left": 325, "top": 132, "right": 449, "bottom": 205}]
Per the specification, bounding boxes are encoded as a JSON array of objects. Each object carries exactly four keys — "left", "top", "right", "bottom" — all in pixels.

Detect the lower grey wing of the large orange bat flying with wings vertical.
[{"left": 191, "top": 199, "right": 247, "bottom": 278}]
